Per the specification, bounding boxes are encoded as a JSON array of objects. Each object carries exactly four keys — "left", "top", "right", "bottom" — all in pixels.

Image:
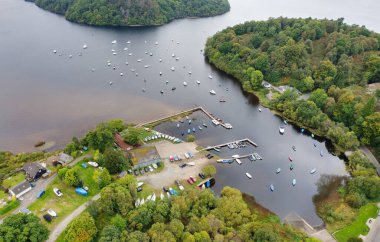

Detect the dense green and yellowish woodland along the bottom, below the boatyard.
[{"left": 62, "top": 181, "right": 316, "bottom": 242}]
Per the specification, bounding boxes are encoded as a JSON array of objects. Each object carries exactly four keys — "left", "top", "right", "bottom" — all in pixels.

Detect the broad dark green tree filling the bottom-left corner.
[{"left": 0, "top": 213, "right": 49, "bottom": 242}]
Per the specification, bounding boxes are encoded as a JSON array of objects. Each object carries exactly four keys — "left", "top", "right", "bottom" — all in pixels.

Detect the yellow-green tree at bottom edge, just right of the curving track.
[{"left": 64, "top": 212, "right": 97, "bottom": 242}]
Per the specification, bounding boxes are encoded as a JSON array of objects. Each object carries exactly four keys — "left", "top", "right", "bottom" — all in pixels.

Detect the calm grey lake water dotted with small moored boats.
[{"left": 0, "top": 0, "right": 380, "bottom": 225}]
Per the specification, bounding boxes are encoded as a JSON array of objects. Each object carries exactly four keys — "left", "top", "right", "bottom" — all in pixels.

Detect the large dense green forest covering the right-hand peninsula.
[{"left": 205, "top": 18, "right": 380, "bottom": 156}]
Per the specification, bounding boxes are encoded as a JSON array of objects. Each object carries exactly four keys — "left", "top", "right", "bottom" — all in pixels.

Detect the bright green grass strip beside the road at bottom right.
[{"left": 334, "top": 203, "right": 378, "bottom": 242}]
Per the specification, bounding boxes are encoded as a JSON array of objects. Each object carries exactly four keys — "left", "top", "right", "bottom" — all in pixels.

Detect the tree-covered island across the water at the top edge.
[{"left": 28, "top": 0, "right": 230, "bottom": 26}]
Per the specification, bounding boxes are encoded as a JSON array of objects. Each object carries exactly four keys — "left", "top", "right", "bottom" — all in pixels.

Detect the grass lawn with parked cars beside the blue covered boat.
[{"left": 28, "top": 162, "right": 100, "bottom": 230}]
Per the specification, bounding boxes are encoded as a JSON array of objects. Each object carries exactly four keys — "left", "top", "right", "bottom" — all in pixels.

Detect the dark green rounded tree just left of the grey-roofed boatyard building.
[{"left": 103, "top": 148, "right": 127, "bottom": 174}]
